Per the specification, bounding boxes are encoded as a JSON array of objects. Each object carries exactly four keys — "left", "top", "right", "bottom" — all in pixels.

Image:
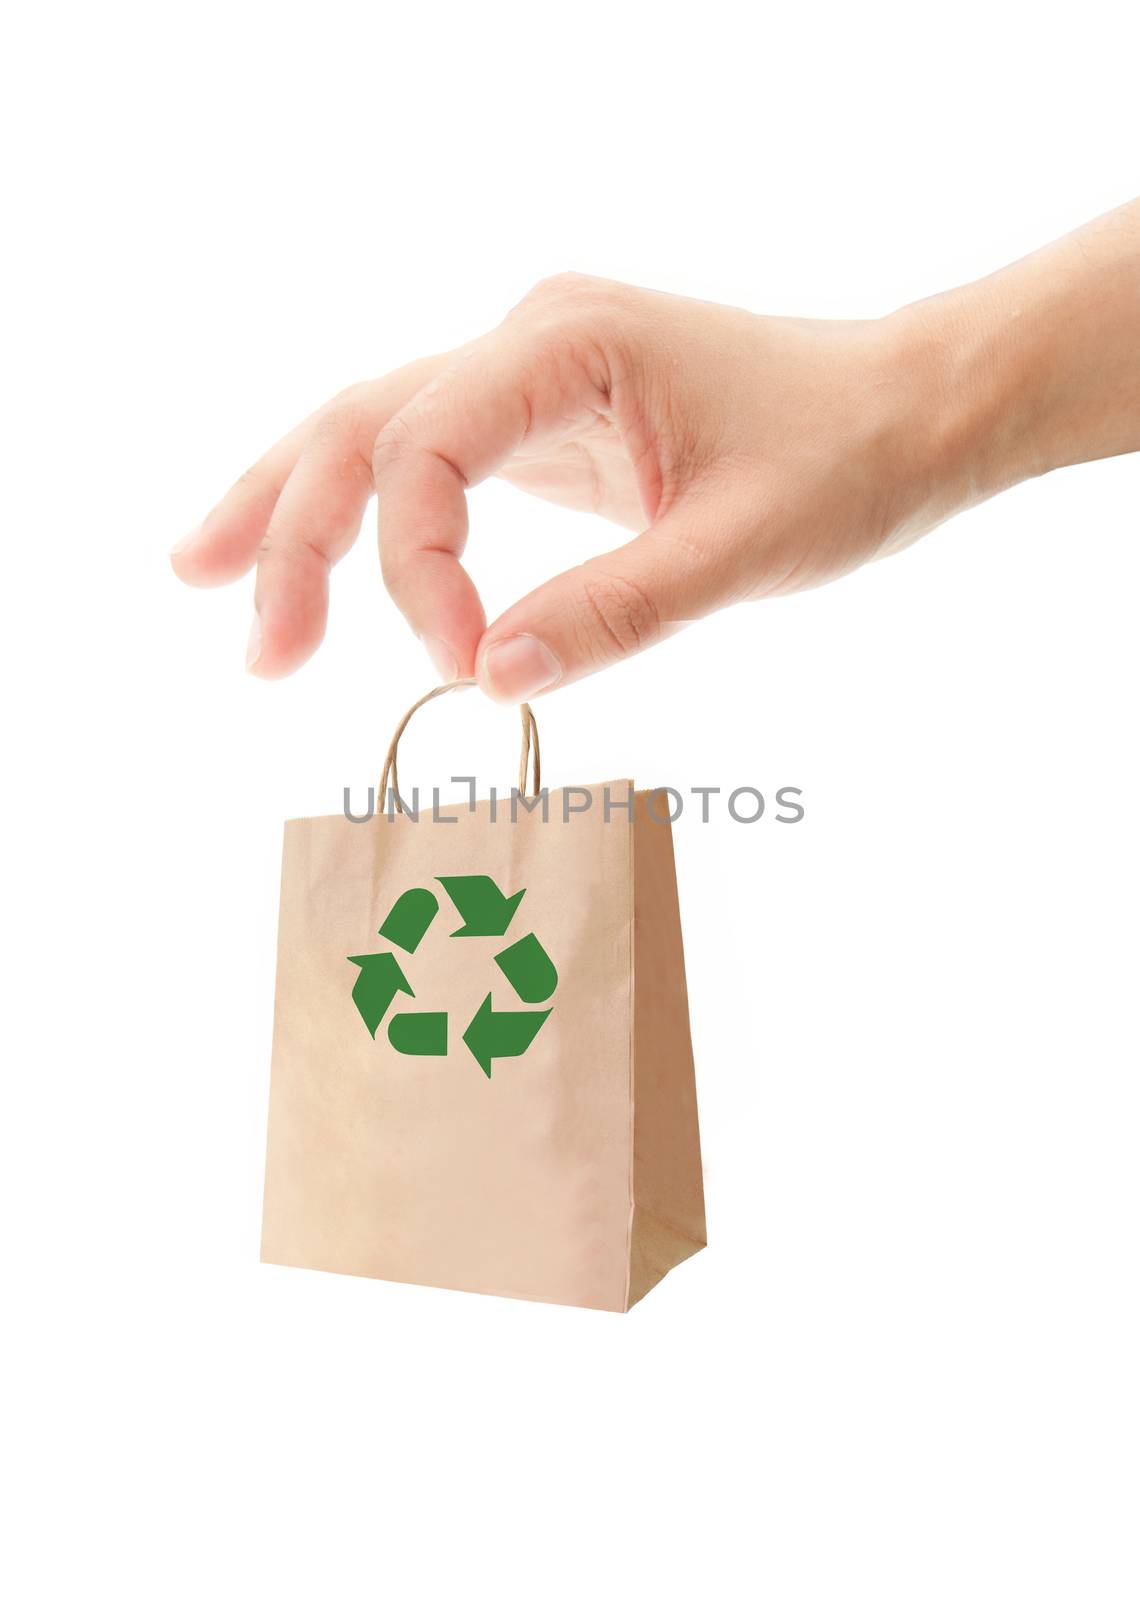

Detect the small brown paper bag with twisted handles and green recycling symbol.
[{"left": 261, "top": 685, "right": 704, "bottom": 1310}]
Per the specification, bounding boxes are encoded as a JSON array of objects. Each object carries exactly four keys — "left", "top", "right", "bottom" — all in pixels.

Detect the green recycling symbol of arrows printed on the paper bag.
[{"left": 349, "top": 874, "right": 559, "bottom": 1077}]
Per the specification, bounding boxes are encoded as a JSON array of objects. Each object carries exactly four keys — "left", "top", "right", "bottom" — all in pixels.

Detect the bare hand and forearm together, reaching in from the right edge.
[{"left": 171, "top": 202, "right": 1140, "bottom": 701}]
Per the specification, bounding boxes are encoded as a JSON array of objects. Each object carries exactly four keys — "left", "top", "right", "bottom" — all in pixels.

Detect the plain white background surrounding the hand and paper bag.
[{"left": 0, "top": 0, "right": 1140, "bottom": 1600}]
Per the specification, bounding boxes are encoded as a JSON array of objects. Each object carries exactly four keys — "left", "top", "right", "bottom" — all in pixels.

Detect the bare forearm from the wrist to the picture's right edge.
[{"left": 898, "top": 202, "right": 1140, "bottom": 515}]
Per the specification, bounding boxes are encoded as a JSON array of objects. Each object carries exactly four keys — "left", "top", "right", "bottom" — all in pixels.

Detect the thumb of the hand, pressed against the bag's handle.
[{"left": 476, "top": 506, "right": 735, "bottom": 702}]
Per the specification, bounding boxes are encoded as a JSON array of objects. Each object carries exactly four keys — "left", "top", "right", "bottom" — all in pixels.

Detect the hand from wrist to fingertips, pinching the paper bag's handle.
[{"left": 175, "top": 277, "right": 954, "bottom": 699}]
